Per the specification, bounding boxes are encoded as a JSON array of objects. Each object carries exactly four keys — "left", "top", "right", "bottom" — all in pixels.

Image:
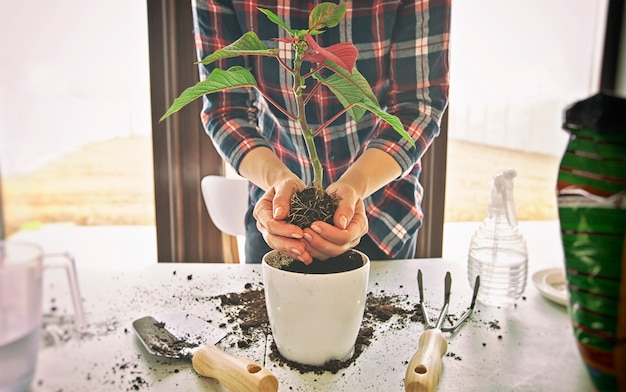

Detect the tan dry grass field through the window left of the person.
[{"left": 2, "top": 137, "right": 155, "bottom": 235}]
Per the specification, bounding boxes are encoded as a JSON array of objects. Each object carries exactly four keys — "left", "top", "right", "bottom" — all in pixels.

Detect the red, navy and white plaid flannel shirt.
[{"left": 193, "top": 0, "right": 451, "bottom": 257}]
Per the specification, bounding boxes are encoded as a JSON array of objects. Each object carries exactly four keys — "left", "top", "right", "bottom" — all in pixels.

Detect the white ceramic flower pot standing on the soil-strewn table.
[{"left": 262, "top": 250, "right": 370, "bottom": 366}]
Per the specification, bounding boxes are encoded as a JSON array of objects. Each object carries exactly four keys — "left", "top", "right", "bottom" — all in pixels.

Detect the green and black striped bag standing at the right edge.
[{"left": 557, "top": 94, "right": 626, "bottom": 391}]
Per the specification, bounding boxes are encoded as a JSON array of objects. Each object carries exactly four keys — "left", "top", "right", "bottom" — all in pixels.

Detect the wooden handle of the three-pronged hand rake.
[{"left": 404, "top": 328, "right": 448, "bottom": 392}]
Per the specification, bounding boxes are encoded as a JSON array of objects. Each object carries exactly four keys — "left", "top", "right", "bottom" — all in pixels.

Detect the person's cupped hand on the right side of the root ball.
[{"left": 303, "top": 182, "right": 368, "bottom": 260}]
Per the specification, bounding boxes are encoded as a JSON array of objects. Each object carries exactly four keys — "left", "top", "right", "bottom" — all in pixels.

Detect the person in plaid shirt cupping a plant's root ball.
[{"left": 193, "top": 0, "right": 451, "bottom": 263}]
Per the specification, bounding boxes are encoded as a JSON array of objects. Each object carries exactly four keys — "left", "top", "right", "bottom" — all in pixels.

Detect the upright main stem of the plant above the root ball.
[{"left": 293, "top": 46, "right": 324, "bottom": 193}]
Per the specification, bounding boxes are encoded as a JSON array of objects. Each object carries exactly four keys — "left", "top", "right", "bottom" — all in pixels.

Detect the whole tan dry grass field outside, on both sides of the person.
[{"left": 2, "top": 137, "right": 559, "bottom": 235}]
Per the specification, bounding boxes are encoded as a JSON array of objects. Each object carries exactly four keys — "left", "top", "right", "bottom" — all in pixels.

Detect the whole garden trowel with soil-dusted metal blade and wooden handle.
[{"left": 133, "top": 313, "right": 278, "bottom": 392}]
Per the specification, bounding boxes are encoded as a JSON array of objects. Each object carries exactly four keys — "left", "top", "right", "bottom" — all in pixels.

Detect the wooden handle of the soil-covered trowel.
[{"left": 191, "top": 344, "right": 278, "bottom": 392}]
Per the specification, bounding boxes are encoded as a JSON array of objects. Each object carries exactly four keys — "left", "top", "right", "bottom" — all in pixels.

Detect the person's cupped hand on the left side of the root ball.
[{"left": 253, "top": 177, "right": 313, "bottom": 264}]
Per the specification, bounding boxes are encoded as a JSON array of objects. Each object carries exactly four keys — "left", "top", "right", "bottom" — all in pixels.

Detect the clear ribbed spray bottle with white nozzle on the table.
[{"left": 467, "top": 169, "right": 528, "bottom": 307}]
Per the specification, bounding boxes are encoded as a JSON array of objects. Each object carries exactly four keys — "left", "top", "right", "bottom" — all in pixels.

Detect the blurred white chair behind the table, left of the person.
[{"left": 200, "top": 175, "right": 248, "bottom": 262}]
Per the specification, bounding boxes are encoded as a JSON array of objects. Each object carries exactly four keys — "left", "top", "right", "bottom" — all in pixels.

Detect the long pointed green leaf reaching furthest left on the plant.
[{"left": 159, "top": 66, "right": 257, "bottom": 121}]
